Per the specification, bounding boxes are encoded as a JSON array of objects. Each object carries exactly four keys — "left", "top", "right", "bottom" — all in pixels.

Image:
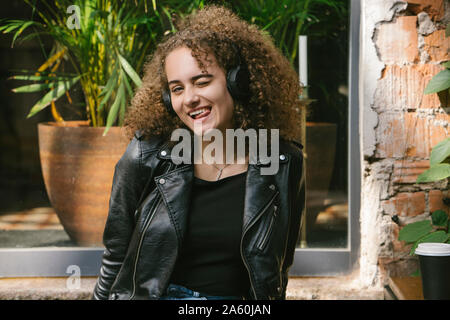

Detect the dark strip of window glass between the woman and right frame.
[{"left": 298, "top": 1, "right": 349, "bottom": 248}]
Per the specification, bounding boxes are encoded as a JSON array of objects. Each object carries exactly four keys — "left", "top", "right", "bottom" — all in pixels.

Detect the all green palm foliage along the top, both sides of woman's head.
[{"left": 0, "top": 0, "right": 348, "bottom": 133}]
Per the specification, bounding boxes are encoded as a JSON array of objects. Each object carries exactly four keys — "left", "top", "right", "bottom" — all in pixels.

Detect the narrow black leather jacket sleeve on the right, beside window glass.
[{"left": 282, "top": 145, "right": 306, "bottom": 297}]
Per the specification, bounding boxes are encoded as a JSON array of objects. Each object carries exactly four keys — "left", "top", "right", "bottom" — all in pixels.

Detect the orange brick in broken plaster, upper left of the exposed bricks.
[{"left": 376, "top": 16, "right": 419, "bottom": 64}]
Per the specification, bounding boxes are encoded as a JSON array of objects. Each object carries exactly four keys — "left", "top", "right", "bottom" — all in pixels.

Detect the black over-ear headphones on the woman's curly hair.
[{"left": 162, "top": 44, "right": 250, "bottom": 116}]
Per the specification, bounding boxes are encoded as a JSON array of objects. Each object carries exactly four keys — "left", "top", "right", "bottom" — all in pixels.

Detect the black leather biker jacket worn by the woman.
[{"left": 92, "top": 134, "right": 305, "bottom": 299}]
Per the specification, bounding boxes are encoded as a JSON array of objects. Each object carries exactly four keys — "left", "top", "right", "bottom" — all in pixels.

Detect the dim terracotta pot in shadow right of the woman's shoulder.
[{"left": 306, "top": 122, "right": 337, "bottom": 232}]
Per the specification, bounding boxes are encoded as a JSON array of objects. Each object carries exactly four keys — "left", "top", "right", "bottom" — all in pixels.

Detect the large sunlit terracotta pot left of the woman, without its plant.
[{"left": 38, "top": 121, "right": 128, "bottom": 246}]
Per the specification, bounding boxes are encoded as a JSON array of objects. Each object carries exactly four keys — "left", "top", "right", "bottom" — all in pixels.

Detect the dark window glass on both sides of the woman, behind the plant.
[{"left": 0, "top": 1, "right": 356, "bottom": 278}]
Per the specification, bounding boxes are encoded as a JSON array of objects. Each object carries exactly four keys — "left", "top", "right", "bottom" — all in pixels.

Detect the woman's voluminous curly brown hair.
[{"left": 125, "top": 5, "right": 304, "bottom": 141}]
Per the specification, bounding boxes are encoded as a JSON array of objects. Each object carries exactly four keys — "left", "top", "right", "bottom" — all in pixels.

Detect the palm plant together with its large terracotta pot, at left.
[{"left": 0, "top": 0, "right": 163, "bottom": 246}]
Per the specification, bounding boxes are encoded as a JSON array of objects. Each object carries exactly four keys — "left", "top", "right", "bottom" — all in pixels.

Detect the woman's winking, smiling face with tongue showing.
[{"left": 165, "top": 47, "right": 234, "bottom": 134}]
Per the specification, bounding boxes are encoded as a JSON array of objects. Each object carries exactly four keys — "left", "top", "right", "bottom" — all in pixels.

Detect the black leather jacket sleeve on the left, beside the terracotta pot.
[{"left": 92, "top": 138, "right": 145, "bottom": 300}]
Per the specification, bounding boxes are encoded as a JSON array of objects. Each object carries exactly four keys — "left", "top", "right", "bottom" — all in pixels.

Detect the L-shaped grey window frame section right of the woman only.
[{"left": 289, "top": 0, "right": 361, "bottom": 276}]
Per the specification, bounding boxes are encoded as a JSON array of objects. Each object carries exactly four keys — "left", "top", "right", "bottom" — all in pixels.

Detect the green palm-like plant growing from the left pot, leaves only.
[{"left": 0, "top": 0, "right": 160, "bottom": 133}]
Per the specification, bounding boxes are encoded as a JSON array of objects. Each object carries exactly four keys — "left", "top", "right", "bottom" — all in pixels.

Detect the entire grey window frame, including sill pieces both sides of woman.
[{"left": 0, "top": 0, "right": 361, "bottom": 278}]
